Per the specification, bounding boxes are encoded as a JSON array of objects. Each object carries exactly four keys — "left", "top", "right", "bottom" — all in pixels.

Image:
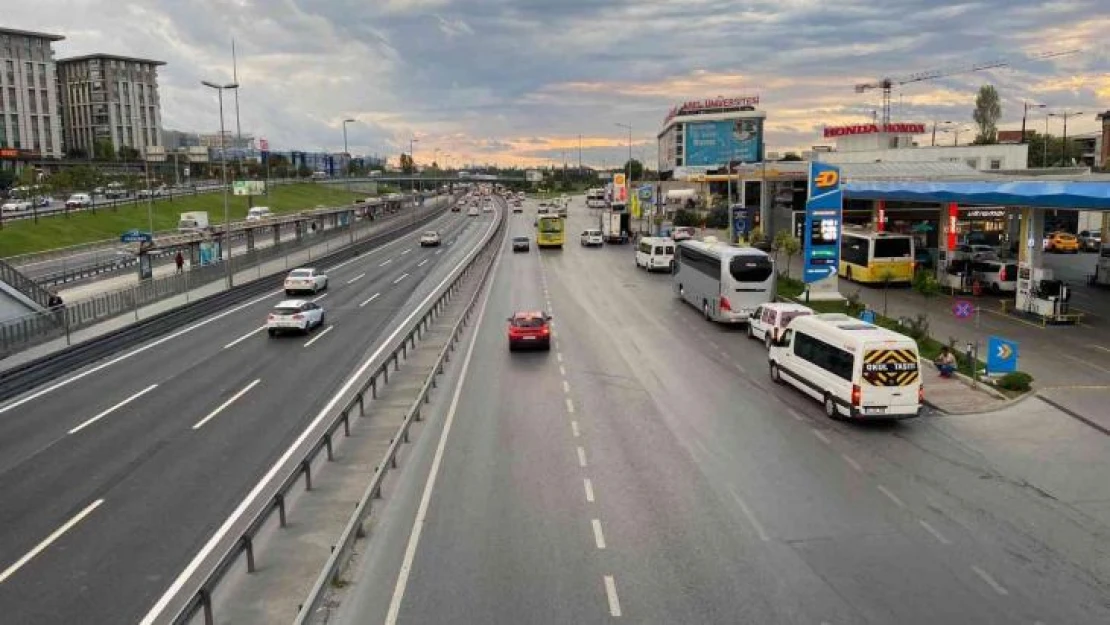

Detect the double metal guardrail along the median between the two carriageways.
[{"left": 159, "top": 199, "right": 507, "bottom": 625}]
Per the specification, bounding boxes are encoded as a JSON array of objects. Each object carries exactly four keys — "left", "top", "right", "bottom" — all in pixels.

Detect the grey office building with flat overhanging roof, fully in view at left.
[{"left": 58, "top": 54, "right": 165, "bottom": 157}]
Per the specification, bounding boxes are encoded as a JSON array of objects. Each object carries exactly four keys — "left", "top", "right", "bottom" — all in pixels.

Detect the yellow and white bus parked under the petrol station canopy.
[{"left": 839, "top": 226, "right": 914, "bottom": 283}]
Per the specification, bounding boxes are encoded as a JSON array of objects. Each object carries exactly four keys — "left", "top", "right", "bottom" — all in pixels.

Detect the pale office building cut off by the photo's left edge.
[{"left": 0, "top": 28, "right": 64, "bottom": 161}]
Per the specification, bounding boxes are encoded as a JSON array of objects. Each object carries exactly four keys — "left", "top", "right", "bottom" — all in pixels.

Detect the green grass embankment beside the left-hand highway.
[{"left": 0, "top": 183, "right": 366, "bottom": 258}]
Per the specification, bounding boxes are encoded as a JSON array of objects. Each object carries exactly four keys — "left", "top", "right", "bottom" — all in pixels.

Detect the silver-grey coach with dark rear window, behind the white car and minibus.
[{"left": 674, "top": 236, "right": 775, "bottom": 323}]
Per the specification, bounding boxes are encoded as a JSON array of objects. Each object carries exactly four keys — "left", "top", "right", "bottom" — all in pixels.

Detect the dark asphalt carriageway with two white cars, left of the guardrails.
[{"left": 0, "top": 199, "right": 492, "bottom": 624}]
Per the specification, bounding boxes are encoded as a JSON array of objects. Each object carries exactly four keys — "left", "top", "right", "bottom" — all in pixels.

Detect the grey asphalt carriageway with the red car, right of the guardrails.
[{"left": 337, "top": 199, "right": 1110, "bottom": 625}]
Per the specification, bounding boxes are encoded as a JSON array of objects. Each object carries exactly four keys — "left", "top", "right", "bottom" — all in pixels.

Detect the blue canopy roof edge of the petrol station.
[{"left": 844, "top": 180, "right": 1110, "bottom": 211}]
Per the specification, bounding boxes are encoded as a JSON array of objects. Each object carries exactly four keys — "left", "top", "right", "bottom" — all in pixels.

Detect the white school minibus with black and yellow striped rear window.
[{"left": 768, "top": 313, "right": 925, "bottom": 419}]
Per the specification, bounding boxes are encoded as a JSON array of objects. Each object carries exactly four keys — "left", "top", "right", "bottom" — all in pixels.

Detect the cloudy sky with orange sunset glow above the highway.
[{"left": 0, "top": 0, "right": 1110, "bottom": 167}]
